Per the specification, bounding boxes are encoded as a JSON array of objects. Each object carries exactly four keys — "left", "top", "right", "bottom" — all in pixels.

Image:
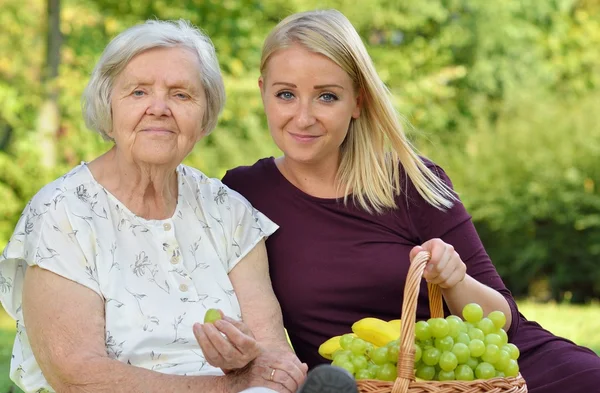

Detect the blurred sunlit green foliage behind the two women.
[{"left": 0, "top": 0, "right": 600, "bottom": 301}]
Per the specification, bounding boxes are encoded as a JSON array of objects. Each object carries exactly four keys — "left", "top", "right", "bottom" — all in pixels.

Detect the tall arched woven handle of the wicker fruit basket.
[{"left": 392, "top": 251, "right": 444, "bottom": 393}]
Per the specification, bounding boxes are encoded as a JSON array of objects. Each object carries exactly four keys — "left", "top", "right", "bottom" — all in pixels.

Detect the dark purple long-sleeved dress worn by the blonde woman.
[{"left": 223, "top": 158, "right": 600, "bottom": 393}]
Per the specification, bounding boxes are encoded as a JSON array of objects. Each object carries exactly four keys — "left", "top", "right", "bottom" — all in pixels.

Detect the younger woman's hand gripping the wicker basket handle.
[{"left": 410, "top": 239, "right": 467, "bottom": 289}]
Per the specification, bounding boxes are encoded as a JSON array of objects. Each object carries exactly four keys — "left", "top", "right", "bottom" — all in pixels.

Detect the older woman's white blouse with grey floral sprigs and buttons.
[{"left": 0, "top": 163, "right": 277, "bottom": 392}]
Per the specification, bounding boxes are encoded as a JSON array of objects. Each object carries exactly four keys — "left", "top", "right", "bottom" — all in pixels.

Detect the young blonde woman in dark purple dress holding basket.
[{"left": 223, "top": 10, "right": 600, "bottom": 393}]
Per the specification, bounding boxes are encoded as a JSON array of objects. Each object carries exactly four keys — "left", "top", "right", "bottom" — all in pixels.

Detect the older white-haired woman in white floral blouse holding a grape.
[{"left": 0, "top": 21, "right": 306, "bottom": 393}]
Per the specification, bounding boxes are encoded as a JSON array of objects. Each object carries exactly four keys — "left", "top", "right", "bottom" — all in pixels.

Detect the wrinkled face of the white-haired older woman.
[{"left": 109, "top": 47, "right": 206, "bottom": 165}]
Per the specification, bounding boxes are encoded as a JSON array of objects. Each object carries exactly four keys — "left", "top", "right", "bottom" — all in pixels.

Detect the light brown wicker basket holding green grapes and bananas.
[{"left": 357, "top": 251, "right": 527, "bottom": 393}]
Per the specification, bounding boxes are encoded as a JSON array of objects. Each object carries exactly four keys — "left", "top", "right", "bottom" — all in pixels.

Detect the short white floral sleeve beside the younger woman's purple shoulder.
[{"left": 223, "top": 186, "right": 279, "bottom": 272}]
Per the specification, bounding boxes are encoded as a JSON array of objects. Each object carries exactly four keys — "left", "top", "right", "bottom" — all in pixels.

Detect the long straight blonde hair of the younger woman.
[{"left": 260, "top": 10, "right": 456, "bottom": 213}]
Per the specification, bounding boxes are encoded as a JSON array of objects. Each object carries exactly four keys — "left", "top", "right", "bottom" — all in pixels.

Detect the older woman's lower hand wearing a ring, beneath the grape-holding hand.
[{"left": 227, "top": 350, "right": 308, "bottom": 393}]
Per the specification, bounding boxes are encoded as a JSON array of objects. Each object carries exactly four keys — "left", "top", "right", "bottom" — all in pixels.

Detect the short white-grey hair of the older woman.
[{"left": 82, "top": 20, "right": 225, "bottom": 140}]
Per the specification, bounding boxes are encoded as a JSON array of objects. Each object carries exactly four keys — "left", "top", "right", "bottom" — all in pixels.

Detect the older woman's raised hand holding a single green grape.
[{"left": 194, "top": 314, "right": 261, "bottom": 374}]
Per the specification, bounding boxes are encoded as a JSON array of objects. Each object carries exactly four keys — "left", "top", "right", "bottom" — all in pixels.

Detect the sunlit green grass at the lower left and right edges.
[{"left": 0, "top": 301, "right": 600, "bottom": 393}]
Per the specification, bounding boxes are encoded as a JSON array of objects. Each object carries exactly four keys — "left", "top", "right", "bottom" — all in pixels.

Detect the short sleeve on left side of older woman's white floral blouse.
[{"left": 0, "top": 198, "right": 101, "bottom": 319}]
